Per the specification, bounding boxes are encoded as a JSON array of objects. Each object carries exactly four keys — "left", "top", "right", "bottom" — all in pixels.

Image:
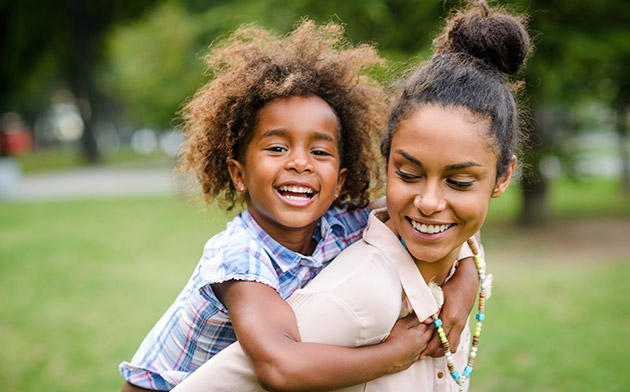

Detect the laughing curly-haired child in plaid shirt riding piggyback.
[{"left": 120, "top": 17, "right": 478, "bottom": 390}]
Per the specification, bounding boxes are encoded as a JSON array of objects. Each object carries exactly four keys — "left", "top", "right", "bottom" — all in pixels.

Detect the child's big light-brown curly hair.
[{"left": 181, "top": 20, "right": 387, "bottom": 210}]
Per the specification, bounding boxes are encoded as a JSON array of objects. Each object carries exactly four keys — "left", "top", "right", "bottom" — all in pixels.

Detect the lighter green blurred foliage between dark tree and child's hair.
[{"left": 100, "top": 2, "right": 203, "bottom": 128}]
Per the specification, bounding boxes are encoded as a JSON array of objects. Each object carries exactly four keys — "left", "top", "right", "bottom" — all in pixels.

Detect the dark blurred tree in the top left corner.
[{"left": 0, "top": 0, "right": 152, "bottom": 161}]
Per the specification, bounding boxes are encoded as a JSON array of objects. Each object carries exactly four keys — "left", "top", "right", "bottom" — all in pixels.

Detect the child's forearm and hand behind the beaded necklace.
[{"left": 421, "top": 257, "right": 479, "bottom": 359}]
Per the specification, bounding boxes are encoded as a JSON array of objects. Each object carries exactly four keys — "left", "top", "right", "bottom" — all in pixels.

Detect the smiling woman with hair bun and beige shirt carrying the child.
[{"left": 175, "top": 2, "right": 529, "bottom": 392}]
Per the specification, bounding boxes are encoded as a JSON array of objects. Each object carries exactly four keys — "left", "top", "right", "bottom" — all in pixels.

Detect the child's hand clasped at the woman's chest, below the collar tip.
[{"left": 382, "top": 313, "right": 435, "bottom": 373}]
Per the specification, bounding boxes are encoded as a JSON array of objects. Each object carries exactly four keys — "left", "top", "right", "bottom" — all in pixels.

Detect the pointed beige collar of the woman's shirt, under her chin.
[{"left": 363, "top": 208, "right": 438, "bottom": 320}]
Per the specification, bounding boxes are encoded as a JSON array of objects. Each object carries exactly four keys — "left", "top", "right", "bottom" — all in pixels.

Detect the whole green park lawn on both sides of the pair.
[{"left": 0, "top": 180, "right": 630, "bottom": 392}]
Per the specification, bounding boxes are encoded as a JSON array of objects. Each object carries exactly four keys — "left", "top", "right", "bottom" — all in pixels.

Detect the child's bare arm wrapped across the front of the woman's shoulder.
[{"left": 209, "top": 281, "right": 432, "bottom": 391}]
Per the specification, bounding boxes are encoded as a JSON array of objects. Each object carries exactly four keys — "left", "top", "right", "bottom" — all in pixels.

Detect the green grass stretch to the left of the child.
[{"left": 0, "top": 198, "right": 232, "bottom": 391}]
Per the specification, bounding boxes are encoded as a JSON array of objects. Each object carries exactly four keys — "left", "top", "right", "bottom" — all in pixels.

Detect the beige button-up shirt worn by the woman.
[{"left": 174, "top": 209, "right": 472, "bottom": 392}]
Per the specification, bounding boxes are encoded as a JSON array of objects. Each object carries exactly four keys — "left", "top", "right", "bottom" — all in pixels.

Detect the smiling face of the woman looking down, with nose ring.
[{"left": 387, "top": 105, "right": 516, "bottom": 267}]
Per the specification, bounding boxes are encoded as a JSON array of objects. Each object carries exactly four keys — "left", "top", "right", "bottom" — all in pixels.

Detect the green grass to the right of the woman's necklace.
[{"left": 471, "top": 257, "right": 630, "bottom": 392}]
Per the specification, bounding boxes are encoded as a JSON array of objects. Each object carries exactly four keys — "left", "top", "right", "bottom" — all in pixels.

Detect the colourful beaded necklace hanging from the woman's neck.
[{"left": 433, "top": 239, "right": 486, "bottom": 391}]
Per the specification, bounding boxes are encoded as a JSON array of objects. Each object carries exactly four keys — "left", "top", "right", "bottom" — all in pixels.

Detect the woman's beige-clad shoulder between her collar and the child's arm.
[{"left": 289, "top": 241, "right": 402, "bottom": 346}]
